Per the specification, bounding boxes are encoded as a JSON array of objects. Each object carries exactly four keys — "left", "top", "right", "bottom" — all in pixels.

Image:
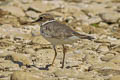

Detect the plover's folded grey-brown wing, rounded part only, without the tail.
[{"left": 42, "top": 21, "right": 73, "bottom": 39}]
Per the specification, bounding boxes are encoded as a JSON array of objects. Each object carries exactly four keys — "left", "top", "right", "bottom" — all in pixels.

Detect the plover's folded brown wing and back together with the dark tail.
[{"left": 43, "top": 21, "right": 93, "bottom": 40}]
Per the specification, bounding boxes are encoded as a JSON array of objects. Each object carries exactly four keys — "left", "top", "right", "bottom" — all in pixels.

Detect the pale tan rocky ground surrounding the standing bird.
[{"left": 0, "top": 0, "right": 120, "bottom": 80}]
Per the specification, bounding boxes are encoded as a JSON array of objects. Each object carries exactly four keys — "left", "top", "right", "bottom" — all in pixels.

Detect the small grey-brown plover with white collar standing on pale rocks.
[{"left": 32, "top": 13, "right": 94, "bottom": 68}]
